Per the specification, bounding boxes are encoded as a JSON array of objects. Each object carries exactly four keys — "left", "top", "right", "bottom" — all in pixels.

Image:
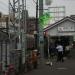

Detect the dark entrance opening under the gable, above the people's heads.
[{"left": 51, "top": 36, "right": 73, "bottom": 46}]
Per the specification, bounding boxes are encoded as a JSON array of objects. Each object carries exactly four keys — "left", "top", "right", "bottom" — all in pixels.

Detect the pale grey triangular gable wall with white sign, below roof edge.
[{"left": 48, "top": 21, "right": 75, "bottom": 36}]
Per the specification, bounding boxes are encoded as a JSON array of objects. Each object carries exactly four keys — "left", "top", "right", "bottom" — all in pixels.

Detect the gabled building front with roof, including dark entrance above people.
[{"left": 44, "top": 16, "right": 75, "bottom": 57}]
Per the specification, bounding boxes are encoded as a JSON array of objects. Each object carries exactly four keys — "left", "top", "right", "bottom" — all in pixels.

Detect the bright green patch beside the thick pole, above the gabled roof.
[{"left": 39, "top": 12, "right": 52, "bottom": 28}]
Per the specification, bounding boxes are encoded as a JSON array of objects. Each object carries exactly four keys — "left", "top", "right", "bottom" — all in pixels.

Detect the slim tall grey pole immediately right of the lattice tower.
[{"left": 22, "top": 0, "right": 27, "bottom": 63}]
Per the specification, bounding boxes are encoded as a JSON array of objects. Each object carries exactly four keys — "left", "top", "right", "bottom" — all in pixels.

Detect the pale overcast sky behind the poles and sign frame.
[{"left": 0, "top": 0, "right": 75, "bottom": 16}]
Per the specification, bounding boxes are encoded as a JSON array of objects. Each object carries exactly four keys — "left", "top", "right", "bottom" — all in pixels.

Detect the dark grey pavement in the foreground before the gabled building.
[{"left": 25, "top": 59, "right": 75, "bottom": 75}]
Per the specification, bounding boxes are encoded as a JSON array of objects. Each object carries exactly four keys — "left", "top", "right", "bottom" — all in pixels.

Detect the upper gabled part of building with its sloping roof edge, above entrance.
[{"left": 44, "top": 17, "right": 75, "bottom": 43}]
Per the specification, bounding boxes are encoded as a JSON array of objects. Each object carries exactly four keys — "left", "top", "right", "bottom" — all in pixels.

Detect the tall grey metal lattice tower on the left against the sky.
[{"left": 9, "top": 0, "right": 22, "bottom": 50}]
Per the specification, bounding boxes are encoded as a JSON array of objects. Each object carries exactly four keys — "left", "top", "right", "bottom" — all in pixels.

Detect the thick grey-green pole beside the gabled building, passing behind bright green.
[{"left": 39, "top": 0, "right": 44, "bottom": 63}]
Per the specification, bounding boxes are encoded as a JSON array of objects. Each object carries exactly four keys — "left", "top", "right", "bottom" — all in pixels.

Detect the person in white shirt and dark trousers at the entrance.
[{"left": 56, "top": 43, "right": 64, "bottom": 62}]
